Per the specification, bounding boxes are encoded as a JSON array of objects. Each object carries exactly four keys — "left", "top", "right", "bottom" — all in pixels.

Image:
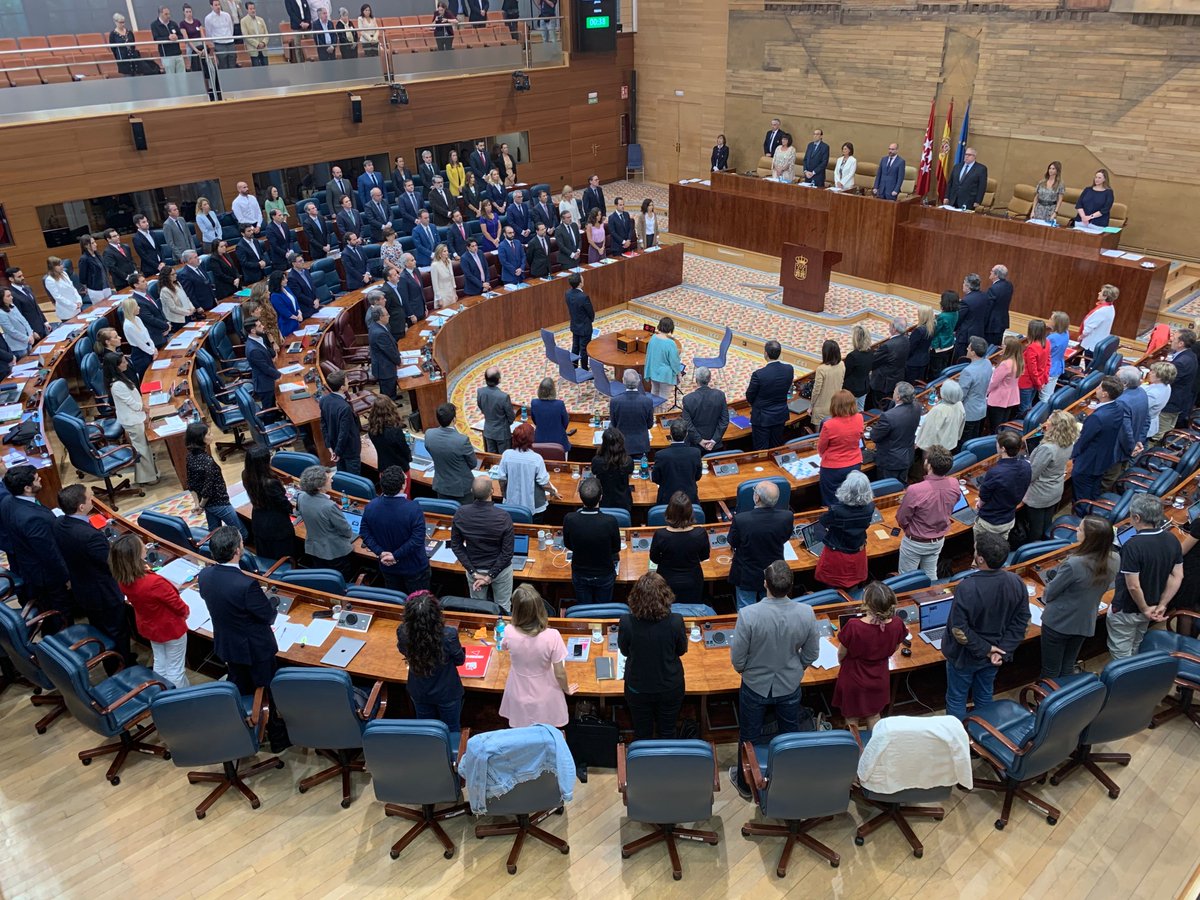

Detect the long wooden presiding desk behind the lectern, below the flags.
[{"left": 670, "top": 173, "right": 1170, "bottom": 336}]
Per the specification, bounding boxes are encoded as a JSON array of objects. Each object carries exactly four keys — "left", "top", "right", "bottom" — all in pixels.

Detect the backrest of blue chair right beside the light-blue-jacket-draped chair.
[{"left": 625, "top": 740, "right": 716, "bottom": 824}]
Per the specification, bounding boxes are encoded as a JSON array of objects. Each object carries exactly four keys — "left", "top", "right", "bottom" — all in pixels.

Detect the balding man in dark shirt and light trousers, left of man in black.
[{"left": 450, "top": 475, "right": 511, "bottom": 614}]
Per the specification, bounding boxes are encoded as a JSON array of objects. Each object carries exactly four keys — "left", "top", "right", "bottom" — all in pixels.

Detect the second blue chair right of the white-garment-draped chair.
[{"left": 1043, "top": 647, "right": 1180, "bottom": 800}]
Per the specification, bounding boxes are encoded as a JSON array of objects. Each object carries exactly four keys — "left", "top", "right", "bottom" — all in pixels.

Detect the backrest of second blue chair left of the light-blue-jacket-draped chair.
[{"left": 271, "top": 667, "right": 366, "bottom": 750}]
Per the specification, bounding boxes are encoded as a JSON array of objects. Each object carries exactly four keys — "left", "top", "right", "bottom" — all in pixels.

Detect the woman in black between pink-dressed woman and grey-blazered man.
[{"left": 617, "top": 572, "right": 688, "bottom": 740}]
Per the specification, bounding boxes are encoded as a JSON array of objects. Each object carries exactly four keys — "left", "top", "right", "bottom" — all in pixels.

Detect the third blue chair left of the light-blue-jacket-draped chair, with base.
[{"left": 150, "top": 682, "right": 283, "bottom": 818}]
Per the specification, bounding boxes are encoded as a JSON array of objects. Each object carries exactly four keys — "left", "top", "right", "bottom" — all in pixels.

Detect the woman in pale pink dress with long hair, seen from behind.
[{"left": 500, "top": 584, "right": 580, "bottom": 728}]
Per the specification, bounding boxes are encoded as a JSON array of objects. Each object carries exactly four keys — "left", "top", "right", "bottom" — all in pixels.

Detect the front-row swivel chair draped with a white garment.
[{"left": 854, "top": 715, "right": 973, "bottom": 859}]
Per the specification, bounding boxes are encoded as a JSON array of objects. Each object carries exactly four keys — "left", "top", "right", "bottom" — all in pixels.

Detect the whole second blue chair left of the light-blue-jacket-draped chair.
[{"left": 271, "top": 667, "right": 388, "bottom": 809}]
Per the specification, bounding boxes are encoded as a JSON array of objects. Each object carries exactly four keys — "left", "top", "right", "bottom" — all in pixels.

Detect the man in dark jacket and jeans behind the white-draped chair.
[{"left": 942, "top": 533, "right": 1030, "bottom": 721}]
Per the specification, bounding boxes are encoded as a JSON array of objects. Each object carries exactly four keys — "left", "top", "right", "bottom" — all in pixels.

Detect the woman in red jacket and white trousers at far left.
[{"left": 108, "top": 534, "right": 191, "bottom": 688}]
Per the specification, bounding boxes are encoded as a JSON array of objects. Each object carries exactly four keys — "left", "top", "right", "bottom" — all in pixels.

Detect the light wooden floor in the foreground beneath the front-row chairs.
[{"left": 0, "top": 672, "right": 1200, "bottom": 900}]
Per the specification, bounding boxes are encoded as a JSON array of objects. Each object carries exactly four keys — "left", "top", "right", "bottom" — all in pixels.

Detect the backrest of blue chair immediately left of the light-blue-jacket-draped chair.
[{"left": 362, "top": 719, "right": 462, "bottom": 805}]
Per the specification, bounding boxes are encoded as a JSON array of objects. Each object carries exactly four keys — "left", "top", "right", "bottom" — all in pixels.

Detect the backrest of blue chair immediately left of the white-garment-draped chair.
[{"left": 758, "top": 731, "right": 858, "bottom": 821}]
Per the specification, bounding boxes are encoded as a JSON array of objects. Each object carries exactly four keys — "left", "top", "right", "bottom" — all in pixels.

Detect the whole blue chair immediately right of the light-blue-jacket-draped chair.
[{"left": 617, "top": 740, "right": 721, "bottom": 881}]
